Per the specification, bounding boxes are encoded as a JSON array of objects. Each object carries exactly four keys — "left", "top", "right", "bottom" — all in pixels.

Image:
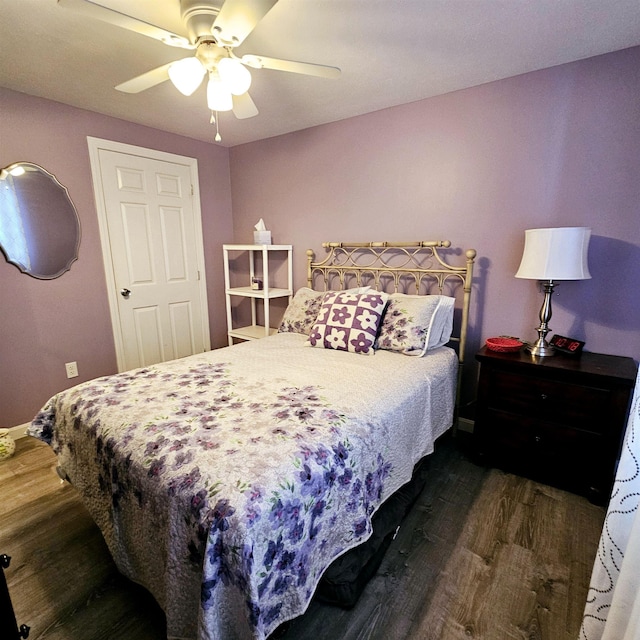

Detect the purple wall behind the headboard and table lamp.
[{"left": 230, "top": 48, "right": 640, "bottom": 404}]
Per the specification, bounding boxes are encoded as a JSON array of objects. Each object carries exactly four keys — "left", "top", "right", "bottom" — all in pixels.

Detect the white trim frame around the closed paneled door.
[{"left": 87, "top": 136, "right": 211, "bottom": 372}]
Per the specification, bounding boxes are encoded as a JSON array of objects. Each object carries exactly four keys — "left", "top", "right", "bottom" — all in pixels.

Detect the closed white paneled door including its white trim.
[{"left": 89, "top": 139, "right": 210, "bottom": 371}]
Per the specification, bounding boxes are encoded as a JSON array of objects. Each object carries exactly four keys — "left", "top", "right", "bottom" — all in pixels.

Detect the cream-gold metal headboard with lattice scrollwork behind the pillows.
[{"left": 307, "top": 240, "right": 476, "bottom": 420}]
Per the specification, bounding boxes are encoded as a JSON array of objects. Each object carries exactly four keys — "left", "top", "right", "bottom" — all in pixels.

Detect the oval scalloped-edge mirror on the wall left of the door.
[{"left": 0, "top": 162, "right": 80, "bottom": 279}]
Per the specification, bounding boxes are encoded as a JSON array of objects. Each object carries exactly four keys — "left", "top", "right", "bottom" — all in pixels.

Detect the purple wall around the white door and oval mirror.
[{"left": 0, "top": 88, "right": 233, "bottom": 427}]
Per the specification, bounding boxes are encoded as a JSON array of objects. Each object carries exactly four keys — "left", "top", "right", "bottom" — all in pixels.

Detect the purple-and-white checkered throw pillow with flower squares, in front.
[{"left": 309, "top": 290, "right": 389, "bottom": 355}]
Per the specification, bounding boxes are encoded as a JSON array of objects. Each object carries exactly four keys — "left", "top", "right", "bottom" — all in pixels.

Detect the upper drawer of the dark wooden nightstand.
[{"left": 488, "top": 370, "right": 610, "bottom": 433}]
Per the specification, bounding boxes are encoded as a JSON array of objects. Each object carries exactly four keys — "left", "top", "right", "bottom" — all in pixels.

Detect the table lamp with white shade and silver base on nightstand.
[{"left": 516, "top": 227, "right": 591, "bottom": 356}]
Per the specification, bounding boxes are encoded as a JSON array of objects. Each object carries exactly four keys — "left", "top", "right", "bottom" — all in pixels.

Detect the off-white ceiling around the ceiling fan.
[{"left": 0, "top": 0, "right": 640, "bottom": 146}]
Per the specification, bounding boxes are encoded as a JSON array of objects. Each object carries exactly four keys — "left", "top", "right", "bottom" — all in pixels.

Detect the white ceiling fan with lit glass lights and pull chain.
[{"left": 58, "top": 0, "right": 340, "bottom": 135}]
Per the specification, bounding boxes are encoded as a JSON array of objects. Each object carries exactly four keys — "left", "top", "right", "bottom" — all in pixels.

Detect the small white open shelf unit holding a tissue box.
[{"left": 222, "top": 244, "right": 293, "bottom": 345}]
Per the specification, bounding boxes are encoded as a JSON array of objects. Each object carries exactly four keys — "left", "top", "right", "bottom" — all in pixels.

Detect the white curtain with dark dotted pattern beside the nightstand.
[{"left": 580, "top": 364, "right": 640, "bottom": 640}]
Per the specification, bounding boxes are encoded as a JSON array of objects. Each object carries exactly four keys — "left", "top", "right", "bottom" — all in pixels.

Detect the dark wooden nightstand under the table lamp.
[{"left": 474, "top": 347, "right": 636, "bottom": 504}]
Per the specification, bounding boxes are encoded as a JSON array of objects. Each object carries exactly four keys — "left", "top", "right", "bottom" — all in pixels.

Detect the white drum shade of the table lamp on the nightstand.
[{"left": 516, "top": 227, "right": 591, "bottom": 280}]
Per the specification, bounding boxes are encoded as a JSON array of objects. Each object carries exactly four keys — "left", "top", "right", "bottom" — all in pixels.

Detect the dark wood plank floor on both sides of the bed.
[{"left": 0, "top": 438, "right": 605, "bottom": 640}]
